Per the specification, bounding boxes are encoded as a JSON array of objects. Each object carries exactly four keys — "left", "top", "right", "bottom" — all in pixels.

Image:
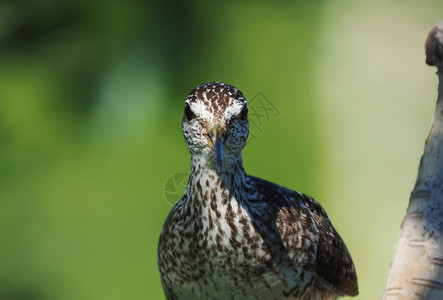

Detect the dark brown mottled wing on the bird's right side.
[{"left": 253, "top": 177, "right": 358, "bottom": 296}]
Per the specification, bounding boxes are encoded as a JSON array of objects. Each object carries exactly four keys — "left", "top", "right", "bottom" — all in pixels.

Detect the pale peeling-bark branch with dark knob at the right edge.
[{"left": 383, "top": 22, "right": 443, "bottom": 300}]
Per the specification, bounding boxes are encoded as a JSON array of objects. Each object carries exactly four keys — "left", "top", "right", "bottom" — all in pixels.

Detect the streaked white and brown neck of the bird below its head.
[{"left": 187, "top": 153, "right": 254, "bottom": 201}]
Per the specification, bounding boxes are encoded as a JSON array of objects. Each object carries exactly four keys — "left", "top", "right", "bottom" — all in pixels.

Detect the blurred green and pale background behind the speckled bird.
[{"left": 0, "top": 0, "right": 443, "bottom": 300}]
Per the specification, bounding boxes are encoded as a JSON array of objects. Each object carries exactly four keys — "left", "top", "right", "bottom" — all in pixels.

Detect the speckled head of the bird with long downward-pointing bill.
[{"left": 182, "top": 82, "right": 249, "bottom": 175}]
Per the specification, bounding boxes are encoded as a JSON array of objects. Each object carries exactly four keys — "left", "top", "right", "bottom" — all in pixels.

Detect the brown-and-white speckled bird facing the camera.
[{"left": 158, "top": 82, "right": 358, "bottom": 300}]
